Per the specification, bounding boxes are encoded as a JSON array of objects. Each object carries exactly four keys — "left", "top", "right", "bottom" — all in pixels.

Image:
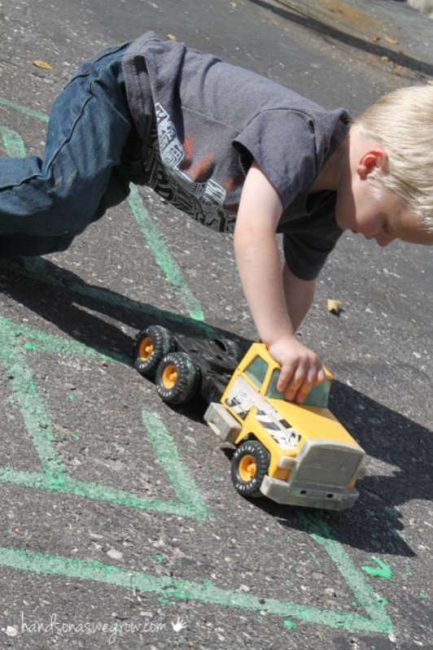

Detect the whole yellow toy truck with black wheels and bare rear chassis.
[{"left": 134, "top": 325, "right": 365, "bottom": 510}]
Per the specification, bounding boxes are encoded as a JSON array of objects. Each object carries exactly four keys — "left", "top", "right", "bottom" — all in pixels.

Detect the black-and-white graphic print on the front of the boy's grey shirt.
[{"left": 146, "top": 102, "right": 235, "bottom": 232}]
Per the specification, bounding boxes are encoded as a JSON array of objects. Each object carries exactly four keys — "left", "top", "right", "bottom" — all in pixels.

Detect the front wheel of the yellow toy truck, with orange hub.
[{"left": 231, "top": 440, "right": 270, "bottom": 497}]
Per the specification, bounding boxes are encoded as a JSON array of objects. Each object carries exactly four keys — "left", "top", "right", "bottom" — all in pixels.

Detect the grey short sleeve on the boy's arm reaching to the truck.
[{"left": 233, "top": 108, "right": 317, "bottom": 209}]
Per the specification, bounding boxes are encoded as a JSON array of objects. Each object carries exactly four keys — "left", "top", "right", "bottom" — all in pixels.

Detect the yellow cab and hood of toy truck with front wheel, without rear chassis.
[{"left": 204, "top": 343, "right": 365, "bottom": 510}]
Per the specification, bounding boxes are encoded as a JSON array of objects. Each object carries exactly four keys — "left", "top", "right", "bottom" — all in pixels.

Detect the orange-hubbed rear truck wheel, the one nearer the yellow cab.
[{"left": 155, "top": 352, "right": 200, "bottom": 406}]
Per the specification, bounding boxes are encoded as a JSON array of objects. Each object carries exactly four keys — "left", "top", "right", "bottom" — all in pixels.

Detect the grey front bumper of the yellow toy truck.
[{"left": 260, "top": 476, "right": 359, "bottom": 510}]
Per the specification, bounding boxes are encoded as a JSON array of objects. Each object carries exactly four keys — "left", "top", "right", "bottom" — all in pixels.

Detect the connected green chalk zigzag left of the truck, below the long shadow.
[{"left": 0, "top": 318, "right": 209, "bottom": 519}]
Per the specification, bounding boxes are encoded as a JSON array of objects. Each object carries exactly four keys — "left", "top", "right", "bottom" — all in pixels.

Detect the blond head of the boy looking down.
[{"left": 337, "top": 86, "right": 433, "bottom": 245}]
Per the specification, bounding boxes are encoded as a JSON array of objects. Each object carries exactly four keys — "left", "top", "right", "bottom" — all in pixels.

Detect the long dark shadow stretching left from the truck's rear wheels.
[{"left": 0, "top": 257, "right": 247, "bottom": 366}]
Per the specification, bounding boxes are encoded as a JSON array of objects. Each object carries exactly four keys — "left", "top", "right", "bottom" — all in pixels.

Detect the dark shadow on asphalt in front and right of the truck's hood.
[{"left": 250, "top": 381, "right": 433, "bottom": 556}]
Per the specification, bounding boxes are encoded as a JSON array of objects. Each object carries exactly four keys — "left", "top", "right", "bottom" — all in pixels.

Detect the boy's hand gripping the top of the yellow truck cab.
[{"left": 269, "top": 336, "right": 325, "bottom": 404}]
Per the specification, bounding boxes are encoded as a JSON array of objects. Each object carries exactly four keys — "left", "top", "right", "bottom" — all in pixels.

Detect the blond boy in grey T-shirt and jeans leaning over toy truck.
[{"left": 0, "top": 32, "right": 433, "bottom": 402}]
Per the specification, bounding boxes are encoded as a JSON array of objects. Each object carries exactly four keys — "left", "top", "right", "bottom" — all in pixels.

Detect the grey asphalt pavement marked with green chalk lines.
[{"left": 0, "top": 0, "right": 433, "bottom": 650}]
